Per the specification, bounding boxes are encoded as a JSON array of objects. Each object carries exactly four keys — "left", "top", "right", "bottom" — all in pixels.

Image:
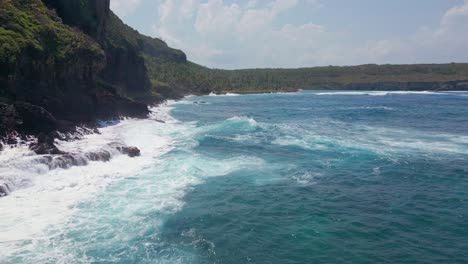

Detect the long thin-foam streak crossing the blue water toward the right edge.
[{"left": 272, "top": 119, "right": 468, "bottom": 157}]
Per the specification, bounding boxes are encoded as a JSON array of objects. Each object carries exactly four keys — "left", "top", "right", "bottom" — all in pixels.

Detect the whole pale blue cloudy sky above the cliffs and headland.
[{"left": 111, "top": 0, "right": 468, "bottom": 69}]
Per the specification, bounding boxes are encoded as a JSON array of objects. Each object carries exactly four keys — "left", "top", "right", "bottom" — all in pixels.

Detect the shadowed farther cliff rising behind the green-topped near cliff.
[{"left": 44, "top": 0, "right": 187, "bottom": 104}]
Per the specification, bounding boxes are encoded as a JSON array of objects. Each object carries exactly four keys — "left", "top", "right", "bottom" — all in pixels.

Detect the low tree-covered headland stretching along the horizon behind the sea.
[{"left": 203, "top": 64, "right": 468, "bottom": 92}]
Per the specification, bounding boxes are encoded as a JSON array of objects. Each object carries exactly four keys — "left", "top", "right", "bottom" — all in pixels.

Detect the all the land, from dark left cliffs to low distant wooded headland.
[{"left": 0, "top": 0, "right": 468, "bottom": 138}]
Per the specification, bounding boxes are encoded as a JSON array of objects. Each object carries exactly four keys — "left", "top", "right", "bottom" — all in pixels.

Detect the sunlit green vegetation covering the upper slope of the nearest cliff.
[{"left": 0, "top": 0, "right": 103, "bottom": 73}]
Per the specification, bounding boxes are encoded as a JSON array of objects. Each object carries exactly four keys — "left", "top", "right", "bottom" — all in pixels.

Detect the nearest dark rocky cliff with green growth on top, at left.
[{"left": 0, "top": 0, "right": 148, "bottom": 134}]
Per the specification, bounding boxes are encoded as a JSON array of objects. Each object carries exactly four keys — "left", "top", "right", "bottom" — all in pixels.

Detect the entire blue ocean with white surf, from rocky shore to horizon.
[{"left": 0, "top": 91, "right": 468, "bottom": 264}]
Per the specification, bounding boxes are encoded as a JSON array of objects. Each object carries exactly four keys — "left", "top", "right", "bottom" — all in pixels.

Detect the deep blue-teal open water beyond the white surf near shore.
[{"left": 163, "top": 92, "right": 468, "bottom": 263}]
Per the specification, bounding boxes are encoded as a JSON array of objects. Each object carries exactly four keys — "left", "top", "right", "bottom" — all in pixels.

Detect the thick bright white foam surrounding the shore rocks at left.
[{"left": 0, "top": 106, "right": 177, "bottom": 259}]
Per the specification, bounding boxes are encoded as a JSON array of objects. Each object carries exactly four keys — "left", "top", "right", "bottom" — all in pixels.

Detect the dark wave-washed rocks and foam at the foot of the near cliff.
[{"left": 0, "top": 103, "right": 174, "bottom": 200}]
